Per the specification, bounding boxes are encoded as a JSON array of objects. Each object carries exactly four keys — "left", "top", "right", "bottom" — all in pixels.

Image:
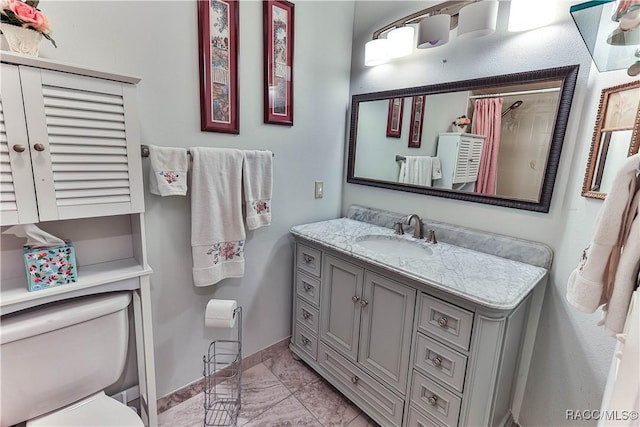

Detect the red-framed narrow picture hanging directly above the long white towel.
[{"left": 198, "top": 0, "right": 240, "bottom": 134}]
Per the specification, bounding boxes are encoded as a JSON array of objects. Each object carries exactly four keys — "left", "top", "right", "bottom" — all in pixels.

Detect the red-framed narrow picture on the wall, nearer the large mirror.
[{"left": 263, "top": 0, "right": 294, "bottom": 126}]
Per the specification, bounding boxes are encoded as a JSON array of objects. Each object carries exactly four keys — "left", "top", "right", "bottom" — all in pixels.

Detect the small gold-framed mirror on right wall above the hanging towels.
[{"left": 582, "top": 80, "right": 640, "bottom": 199}]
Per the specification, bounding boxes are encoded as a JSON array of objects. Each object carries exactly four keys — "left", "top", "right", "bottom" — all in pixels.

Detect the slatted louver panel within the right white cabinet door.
[{"left": 42, "top": 85, "right": 131, "bottom": 207}]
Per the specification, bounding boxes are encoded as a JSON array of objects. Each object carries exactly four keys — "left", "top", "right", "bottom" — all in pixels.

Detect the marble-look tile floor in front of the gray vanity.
[{"left": 158, "top": 348, "right": 377, "bottom": 427}]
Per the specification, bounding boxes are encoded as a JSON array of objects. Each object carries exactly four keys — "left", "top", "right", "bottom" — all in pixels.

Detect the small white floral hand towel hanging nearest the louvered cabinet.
[{"left": 149, "top": 145, "right": 189, "bottom": 196}]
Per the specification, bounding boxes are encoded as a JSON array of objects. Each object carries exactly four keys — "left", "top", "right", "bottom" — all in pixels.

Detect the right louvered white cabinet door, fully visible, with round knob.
[{"left": 20, "top": 67, "right": 144, "bottom": 221}]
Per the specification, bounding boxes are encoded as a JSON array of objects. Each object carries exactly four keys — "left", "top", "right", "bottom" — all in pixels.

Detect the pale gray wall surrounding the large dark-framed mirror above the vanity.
[{"left": 342, "top": 1, "right": 633, "bottom": 426}]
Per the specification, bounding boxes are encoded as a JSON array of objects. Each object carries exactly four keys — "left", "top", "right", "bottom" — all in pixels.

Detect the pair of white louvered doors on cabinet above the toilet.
[{"left": 0, "top": 63, "right": 143, "bottom": 225}]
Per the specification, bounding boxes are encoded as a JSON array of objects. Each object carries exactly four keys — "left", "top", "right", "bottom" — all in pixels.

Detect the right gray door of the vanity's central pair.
[{"left": 358, "top": 271, "right": 416, "bottom": 394}]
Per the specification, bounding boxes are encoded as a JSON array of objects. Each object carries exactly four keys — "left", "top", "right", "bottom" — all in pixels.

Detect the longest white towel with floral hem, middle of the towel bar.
[{"left": 189, "top": 147, "right": 246, "bottom": 286}]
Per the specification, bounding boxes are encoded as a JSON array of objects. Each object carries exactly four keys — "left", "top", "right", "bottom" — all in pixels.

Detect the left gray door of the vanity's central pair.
[{"left": 320, "top": 255, "right": 364, "bottom": 362}]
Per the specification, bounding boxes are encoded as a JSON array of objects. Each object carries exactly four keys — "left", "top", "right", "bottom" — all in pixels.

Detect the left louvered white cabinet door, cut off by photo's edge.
[{"left": 0, "top": 64, "right": 38, "bottom": 225}]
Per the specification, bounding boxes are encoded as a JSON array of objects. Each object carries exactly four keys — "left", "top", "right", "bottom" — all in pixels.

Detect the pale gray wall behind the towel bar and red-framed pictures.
[{"left": 41, "top": 1, "right": 354, "bottom": 397}]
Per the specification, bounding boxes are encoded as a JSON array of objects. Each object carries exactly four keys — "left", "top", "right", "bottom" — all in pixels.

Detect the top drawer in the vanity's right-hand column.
[{"left": 418, "top": 294, "right": 473, "bottom": 350}]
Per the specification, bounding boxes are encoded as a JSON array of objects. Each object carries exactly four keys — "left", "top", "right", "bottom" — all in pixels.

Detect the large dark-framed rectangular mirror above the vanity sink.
[{"left": 347, "top": 65, "right": 579, "bottom": 212}]
